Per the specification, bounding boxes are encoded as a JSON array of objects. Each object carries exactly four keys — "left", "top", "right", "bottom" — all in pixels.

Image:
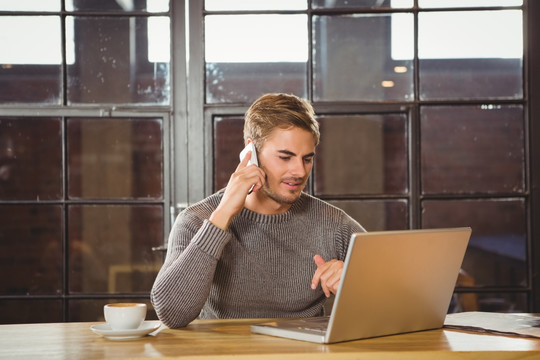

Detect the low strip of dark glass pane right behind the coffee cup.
[{"left": 68, "top": 297, "right": 158, "bottom": 322}]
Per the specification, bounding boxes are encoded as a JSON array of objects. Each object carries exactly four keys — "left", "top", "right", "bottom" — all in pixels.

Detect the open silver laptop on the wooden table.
[{"left": 251, "top": 228, "right": 471, "bottom": 344}]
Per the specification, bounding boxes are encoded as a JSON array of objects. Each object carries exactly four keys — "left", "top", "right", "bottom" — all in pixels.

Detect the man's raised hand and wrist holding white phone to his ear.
[{"left": 209, "top": 141, "right": 265, "bottom": 230}]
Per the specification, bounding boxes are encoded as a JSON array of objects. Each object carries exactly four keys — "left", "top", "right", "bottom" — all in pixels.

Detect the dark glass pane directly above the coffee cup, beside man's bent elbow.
[{"left": 68, "top": 205, "right": 163, "bottom": 294}]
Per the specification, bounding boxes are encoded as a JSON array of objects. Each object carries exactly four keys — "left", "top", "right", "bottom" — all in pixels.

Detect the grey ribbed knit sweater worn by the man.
[{"left": 151, "top": 192, "right": 365, "bottom": 328}]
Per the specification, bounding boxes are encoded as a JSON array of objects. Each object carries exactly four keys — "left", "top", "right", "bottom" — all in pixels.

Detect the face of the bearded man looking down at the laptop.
[{"left": 258, "top": 127, "right": 315, "bottom": 205}]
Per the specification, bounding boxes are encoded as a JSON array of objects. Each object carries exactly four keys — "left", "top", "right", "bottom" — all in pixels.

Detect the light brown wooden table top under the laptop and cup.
[{"left": 0, "top": 319, "right": 540, "bottom": 360}]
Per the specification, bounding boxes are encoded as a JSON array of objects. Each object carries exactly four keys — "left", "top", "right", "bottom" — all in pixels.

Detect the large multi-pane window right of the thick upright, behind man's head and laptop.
[{"left": 204, "top": 0, "right": 532, "bottom": 311}]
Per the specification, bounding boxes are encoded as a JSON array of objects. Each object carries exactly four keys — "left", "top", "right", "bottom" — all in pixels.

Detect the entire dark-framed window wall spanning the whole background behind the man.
[{"left": 0, "top": 0, "right": 540, "bottom": 323}]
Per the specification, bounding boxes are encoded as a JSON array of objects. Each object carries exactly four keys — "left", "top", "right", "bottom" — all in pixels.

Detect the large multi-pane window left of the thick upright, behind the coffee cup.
[{"left": 0, "top": 0, "right": 171, "bottom": 323}]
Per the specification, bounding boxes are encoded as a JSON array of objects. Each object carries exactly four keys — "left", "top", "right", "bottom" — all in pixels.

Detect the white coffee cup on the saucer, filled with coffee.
[{"left": 103, "top": 303, "right": 146, "bottom": 330}]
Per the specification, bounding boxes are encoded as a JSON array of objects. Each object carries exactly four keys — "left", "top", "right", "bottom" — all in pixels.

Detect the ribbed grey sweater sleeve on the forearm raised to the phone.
[{"left": 150, "top": 214, "right": 230, "bottom": 328}]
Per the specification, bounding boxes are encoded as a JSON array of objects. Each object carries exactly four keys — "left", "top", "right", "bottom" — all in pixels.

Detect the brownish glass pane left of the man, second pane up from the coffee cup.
[{"left": 67, "top": 118, "right": 164, "bottom": 199}]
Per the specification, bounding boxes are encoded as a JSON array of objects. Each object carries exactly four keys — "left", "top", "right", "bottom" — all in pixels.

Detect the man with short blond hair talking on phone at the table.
[{"left": 151, "top": 94, "right": 365, "bottom": 328}]
